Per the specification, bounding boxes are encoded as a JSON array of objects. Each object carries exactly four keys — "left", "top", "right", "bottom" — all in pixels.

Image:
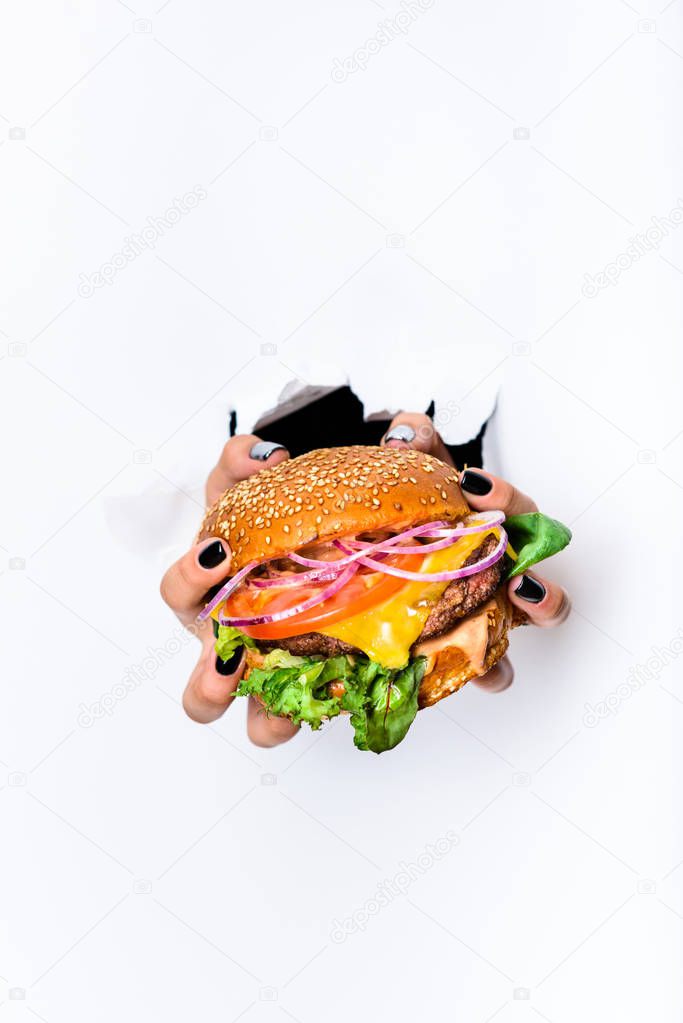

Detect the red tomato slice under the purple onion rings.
[{"left": 224, "top": 554, "right": 424, "bottom": 639}]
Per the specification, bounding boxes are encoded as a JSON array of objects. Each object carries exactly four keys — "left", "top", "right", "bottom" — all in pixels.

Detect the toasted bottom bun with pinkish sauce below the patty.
[{"left": 412, "top": 587, "right": 525, "bottom": 708}]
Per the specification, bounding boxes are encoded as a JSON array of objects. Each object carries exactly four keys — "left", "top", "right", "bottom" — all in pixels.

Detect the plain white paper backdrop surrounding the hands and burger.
[{"left": 0, "top": 0, "right": 683, "bottom": 1023}]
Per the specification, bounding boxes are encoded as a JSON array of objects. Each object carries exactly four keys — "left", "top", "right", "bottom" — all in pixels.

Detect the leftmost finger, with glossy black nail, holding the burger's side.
[{"left": 160, "top": 536, "right": 230, "bottom": 625}]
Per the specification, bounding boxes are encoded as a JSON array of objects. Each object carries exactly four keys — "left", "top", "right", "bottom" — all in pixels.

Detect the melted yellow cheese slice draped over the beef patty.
[{"left": 316, "top": 529, "right": 500, "bottom": 668}]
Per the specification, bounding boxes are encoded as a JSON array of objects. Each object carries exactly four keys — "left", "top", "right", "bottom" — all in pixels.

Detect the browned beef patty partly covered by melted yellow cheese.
[{"left": 259, "top": 536, "right": 503, "bottom": 657}]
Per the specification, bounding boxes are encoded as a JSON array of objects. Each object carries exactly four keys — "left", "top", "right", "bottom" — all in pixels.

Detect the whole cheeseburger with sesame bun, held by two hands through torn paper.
[{"left": 197, "top": 446, "right": 571, "bottom": 753}]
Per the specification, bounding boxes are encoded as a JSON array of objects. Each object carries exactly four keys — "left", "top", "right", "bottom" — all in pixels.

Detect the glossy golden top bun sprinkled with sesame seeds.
[{"left": 197, "top": 445, "right": 469, "bottom": 574}]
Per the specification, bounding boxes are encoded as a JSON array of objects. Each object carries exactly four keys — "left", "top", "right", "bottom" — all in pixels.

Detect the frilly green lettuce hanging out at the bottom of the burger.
[{"left": 237, "top": 650, "right": 425, "bottom": 753}]
